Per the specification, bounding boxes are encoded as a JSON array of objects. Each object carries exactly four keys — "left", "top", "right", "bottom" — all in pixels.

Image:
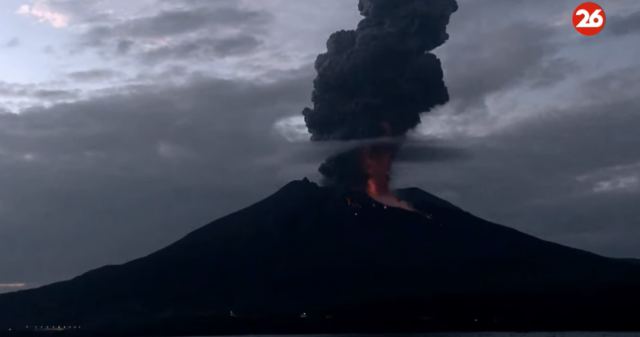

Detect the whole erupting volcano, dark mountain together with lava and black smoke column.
[{"left": 0, "top": 0, "right": 640, "bottom": 337}]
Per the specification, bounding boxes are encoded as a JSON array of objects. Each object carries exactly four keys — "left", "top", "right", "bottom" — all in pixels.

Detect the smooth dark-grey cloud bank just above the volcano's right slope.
[{"left": 396, "top": 92, "right": 640, "bottom": 256}]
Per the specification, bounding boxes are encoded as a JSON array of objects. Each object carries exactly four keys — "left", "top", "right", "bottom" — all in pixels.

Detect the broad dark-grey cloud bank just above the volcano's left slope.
[{"left": 0, "top": 72, "right": 313, "bottom": 283}]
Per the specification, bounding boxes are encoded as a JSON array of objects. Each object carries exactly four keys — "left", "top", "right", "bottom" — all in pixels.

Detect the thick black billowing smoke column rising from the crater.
[{"left": 303, "top": 0, "right": 458, "bottom": 205}]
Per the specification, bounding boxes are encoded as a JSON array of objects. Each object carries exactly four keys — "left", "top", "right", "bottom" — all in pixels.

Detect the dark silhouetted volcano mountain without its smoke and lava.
[{"left": 0, "top": 179, "right": 640, "bottom": 335}]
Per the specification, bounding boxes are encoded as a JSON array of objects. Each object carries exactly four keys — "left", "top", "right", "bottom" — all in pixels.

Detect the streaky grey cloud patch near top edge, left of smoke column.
[{"left": 80, "top": 2, "right": 272, "bottom": 64}]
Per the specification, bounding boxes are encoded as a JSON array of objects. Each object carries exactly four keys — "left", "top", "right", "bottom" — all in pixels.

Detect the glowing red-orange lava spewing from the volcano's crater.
[{"left": 362, "top": 145, "right": 415, "bottom": 211}]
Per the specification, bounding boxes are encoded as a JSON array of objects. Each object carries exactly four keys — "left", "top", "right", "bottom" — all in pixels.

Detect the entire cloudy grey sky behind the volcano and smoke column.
[{"left": 0, "top": 0, "right": 640, "bottom": 292}]
